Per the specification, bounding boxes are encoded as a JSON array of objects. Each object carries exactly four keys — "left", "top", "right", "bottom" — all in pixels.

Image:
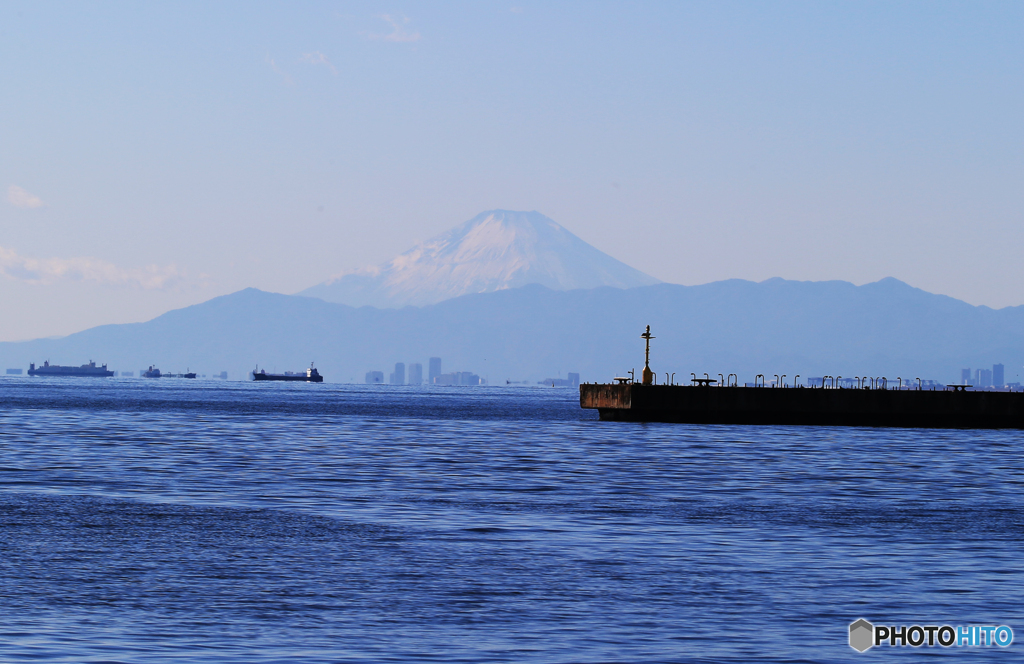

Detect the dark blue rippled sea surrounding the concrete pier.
[{"left": 0, "top": 378, "right": 1024, "bottom": 663}]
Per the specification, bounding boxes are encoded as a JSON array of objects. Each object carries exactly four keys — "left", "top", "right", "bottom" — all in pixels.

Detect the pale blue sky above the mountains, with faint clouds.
[{"left": 0, "top": 2, "right": 1024, "bottom": 340}]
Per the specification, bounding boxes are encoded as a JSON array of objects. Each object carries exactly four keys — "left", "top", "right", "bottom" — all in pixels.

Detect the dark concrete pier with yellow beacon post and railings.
[{"left": 580, "top": 326, "right": 1024, "bottom": 428}]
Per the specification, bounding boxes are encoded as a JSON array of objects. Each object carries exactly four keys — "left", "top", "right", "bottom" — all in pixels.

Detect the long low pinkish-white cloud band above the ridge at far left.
[{"left": 0, "top": 247, "right": 184, "bottom": 290}]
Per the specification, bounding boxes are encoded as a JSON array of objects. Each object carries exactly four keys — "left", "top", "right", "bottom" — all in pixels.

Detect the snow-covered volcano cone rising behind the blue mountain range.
[{"left": 299, "top": 210, "right": 658, "bottom": 307}]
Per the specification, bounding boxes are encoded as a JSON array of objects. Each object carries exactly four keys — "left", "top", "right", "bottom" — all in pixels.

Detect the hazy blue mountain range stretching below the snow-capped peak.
[{"left": 0, "top": 279, "right": 1024, "bottom": 384}]
